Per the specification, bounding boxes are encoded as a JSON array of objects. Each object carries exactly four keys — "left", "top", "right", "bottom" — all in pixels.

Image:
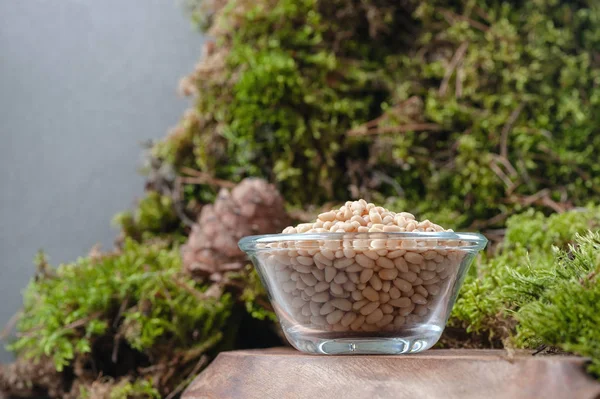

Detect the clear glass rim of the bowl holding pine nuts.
[{"left": 238, "top": 231, "right": 488, "bottom": 252}]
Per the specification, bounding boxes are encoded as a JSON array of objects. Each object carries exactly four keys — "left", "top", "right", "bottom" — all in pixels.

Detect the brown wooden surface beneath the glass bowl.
[{"left": 182, "top": 348, "right": 600, "bottom": 399}]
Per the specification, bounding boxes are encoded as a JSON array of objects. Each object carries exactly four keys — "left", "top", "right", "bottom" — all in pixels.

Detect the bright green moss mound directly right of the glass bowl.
[{"left": 450, "top": 207, "right": 600, "bottom": 339}]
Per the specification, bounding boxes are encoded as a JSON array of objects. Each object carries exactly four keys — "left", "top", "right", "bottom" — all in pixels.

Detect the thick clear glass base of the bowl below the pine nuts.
[{"left": 286, "top": 325, "right": 443, "bottom": 355}]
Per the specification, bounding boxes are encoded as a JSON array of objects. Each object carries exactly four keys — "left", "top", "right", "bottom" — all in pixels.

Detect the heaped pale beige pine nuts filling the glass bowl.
[{"left": 258, "top": 200, "right": 466, "bottom": 332}]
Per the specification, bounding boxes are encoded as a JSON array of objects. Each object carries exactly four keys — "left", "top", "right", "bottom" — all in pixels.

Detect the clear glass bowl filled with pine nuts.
[{"left": 239, "top": 232, "right": 487, "bottom": 354}]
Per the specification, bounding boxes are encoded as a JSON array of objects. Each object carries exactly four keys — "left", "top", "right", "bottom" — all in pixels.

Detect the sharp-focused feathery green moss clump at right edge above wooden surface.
[{"left": 515, "top": 232, "right": 600, "bottom": 377}]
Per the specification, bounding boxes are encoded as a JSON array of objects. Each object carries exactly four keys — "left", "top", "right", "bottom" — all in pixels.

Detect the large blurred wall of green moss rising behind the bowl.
[{"left": 139, "top": 0, "right": 600, "bottom": 228}]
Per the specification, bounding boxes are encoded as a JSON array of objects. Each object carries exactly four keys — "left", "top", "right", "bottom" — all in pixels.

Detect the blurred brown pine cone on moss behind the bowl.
[{"left": 182, "top": 178, "right": 289, "bottom": 281}]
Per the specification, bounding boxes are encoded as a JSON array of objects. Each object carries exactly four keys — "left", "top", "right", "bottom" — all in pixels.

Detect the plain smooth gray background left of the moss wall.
[{"left": 0, "top": 0, "right": 202, "bottom": 362}]
